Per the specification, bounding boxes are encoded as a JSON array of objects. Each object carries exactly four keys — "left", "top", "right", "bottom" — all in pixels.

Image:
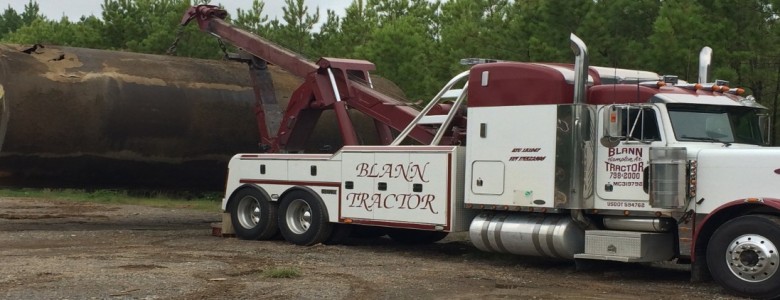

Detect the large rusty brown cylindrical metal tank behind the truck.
[{"left": 0, "top": 45, "right": 402, "bottom": 190}]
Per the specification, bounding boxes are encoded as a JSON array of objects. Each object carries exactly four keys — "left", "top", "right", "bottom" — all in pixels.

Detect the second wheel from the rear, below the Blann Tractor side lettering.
[{"left": 278, "top": 191, "right": 333, "bottom": 246}]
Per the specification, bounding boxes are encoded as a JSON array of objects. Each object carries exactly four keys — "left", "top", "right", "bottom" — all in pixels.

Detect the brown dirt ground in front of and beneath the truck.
[{"left": 0, "top": 198, "right": 732, "bottom": 299}]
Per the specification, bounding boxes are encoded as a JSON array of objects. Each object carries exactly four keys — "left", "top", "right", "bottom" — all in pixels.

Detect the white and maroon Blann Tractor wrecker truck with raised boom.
[{"left": 182, "top": 5, "right": 780, "bottom": 298}]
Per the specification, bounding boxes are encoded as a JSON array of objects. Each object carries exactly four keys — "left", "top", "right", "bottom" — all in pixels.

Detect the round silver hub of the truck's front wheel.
[{"left": 726, "top": 234, "right": 780, "bottom": 282}]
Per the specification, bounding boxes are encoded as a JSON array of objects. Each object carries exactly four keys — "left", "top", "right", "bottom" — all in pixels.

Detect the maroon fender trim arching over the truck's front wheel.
[{"left": 691, "top": 198, "right": 780, "bottom": 262}]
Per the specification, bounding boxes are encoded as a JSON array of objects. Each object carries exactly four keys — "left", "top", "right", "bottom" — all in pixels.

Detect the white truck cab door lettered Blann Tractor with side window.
[{"left": 596, "top": 104, "right": 666, "bottom": 209}]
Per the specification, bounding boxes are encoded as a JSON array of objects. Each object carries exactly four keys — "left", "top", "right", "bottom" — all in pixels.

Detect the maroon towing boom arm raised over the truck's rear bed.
[{"left": 181, "top": 5, "right": 454, "bottom": 152}]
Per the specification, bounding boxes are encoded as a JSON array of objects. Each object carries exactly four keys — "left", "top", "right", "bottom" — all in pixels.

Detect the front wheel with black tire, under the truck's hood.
[{"left": 707, "top": 215, "right": 780, "bottom": 299}]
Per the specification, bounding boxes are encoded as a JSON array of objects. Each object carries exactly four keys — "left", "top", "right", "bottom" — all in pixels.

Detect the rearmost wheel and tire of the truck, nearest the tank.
[{"left": 228, "top": 189, "right": 279, "bottom": 240}]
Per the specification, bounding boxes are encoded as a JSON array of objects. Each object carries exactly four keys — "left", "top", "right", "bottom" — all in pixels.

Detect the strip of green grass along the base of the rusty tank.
[{"left": 0, "top": 188, "right": 222, "bottom": 211}]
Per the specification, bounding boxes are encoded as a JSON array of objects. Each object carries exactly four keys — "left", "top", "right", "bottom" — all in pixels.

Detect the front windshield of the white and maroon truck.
[{"left": 667, "top": 103, "right": 763, "bottom": 145}]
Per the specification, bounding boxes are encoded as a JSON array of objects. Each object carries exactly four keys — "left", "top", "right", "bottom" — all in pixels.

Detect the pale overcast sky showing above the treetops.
[{"left": 0, "top": 0, "right": 352, "bottom": 22}]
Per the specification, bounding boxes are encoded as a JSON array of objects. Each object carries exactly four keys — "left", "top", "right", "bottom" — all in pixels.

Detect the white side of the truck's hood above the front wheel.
[{"left": 695, "top": 148, "right": 780, "bottom": 213}]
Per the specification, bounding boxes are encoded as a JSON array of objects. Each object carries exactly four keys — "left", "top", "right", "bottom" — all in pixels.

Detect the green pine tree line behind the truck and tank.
[{"left": 0, "top": 0, "right": 780, "bottom": 144}]
